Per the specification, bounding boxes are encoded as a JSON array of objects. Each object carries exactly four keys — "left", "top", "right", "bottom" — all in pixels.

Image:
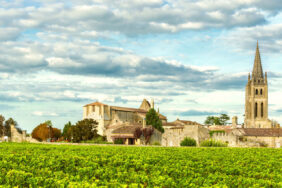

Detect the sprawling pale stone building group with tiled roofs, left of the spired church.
[{"left": 83, "top": 99, "right": 208, "bottom": 146}]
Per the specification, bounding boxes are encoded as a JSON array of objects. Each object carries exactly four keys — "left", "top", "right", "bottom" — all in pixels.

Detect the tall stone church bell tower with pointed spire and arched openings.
[{"left": 244, "top": 43, "right": 271, "bottom": 128}]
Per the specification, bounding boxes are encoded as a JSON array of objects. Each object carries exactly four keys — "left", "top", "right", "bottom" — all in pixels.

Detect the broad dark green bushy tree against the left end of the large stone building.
[{"left": 70, "top": 119, "right": 99, "bottom": 142}]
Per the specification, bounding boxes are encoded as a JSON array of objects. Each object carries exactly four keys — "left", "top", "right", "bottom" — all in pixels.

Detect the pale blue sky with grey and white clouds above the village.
[{"left": 0, "top": 0, "right": 282, "bottom": 132}]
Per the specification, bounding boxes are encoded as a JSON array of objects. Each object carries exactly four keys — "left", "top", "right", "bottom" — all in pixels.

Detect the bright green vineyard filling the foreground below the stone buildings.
[{"left": 0, "top": 143, "right": 282, "bottom": 187}]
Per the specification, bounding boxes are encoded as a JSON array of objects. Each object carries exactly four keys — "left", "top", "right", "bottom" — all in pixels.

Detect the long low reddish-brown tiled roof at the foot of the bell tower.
[{"left": 241, "top": 128, "right": 282, "bottom": 137}]
